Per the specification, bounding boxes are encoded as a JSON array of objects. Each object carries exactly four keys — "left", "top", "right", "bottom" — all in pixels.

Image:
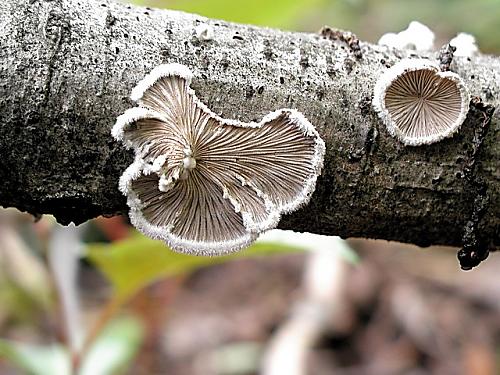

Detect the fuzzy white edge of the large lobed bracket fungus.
[{"left": 112, "top": 63, "right": 325, "bottom": 255}]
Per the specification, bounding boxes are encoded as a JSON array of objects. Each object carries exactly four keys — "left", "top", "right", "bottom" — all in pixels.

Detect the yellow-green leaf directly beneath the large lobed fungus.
[{"left": 87, "top": 234, "right": 302, "bottom": 299}]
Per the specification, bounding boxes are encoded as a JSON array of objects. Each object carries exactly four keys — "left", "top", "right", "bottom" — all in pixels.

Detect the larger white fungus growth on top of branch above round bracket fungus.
[{"left": 378, "top": 21, "right": 435, "bottom": 51}]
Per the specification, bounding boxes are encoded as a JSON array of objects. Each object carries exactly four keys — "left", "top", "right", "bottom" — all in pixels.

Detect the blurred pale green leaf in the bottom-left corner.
[{"left": 0, "top": 339, "right": 71, "bottom": 375}]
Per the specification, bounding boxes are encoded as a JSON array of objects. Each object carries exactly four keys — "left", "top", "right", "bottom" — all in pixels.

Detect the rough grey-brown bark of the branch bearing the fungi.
[{"left": 0, "top": 0, "right": 500, "bottom": 250}]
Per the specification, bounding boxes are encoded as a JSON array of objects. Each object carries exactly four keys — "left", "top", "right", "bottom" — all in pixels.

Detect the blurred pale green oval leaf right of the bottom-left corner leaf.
[{"left": 78, "top": 317, "right": 143, "bottom": 375}]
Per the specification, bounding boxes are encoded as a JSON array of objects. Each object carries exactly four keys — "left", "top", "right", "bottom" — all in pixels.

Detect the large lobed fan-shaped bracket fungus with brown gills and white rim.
[{"left": 112, "top": 64, "right": 325, "bottom": 255}]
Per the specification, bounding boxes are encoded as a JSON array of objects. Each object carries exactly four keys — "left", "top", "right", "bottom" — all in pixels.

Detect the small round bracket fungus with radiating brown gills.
[{"left": 372, "top": 59, "right": 469, "bottom": 146}]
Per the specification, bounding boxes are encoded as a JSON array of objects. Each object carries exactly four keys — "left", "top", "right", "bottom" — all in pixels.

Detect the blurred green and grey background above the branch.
[{"left": 132, "top": 0, "right": 500, "bottom": 53}]
